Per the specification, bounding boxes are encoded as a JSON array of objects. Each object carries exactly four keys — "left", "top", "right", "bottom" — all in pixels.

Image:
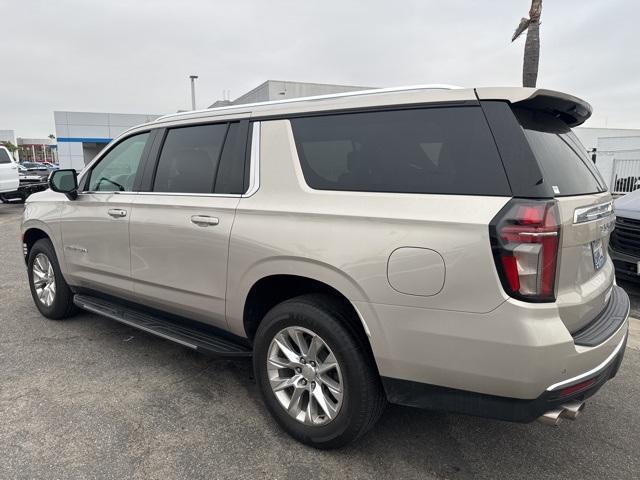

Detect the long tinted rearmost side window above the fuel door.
[{"left": 291, "top": 107, "right": 510, "bottom": 195}]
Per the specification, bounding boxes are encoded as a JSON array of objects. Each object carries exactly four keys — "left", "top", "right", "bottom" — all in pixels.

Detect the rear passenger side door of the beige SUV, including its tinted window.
[{"left": 130, "top": 121, "right": 248, "bottom": 327}]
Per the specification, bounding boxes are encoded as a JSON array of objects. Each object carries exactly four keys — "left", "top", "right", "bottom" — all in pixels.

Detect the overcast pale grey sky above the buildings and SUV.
[{"left": 0, "top": 0, "right": 640, "bottom": 137}]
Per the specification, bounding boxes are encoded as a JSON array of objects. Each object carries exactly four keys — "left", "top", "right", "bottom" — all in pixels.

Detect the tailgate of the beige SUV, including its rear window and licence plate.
[{"left": 514, "top": 108, "right": 614, "bottom": 332}]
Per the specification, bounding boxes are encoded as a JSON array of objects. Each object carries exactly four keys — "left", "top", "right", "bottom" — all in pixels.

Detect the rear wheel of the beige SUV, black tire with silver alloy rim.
[{"left": 253, "top": 294, "right": 386, "bottom": 449}]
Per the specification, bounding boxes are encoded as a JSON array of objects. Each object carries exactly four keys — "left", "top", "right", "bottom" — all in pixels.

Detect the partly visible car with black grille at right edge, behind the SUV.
[{"left": 609, "top": 190, "right": 640, "bottom": 281}]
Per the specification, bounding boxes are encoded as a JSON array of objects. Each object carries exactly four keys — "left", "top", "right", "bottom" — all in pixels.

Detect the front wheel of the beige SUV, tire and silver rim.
[{"left": 27, "top": 238, "right": 78, "bottom": 320}]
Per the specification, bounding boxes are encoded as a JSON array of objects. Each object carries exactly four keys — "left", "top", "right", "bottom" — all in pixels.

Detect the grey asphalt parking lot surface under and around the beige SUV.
[{"left": 0, "top": 205, "right": 640, "bottom": 480}]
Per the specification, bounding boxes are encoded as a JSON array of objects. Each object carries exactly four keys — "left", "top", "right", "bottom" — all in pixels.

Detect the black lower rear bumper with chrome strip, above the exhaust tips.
[{"left": 382, "top": 328, "right": 627, "bottom": 423}]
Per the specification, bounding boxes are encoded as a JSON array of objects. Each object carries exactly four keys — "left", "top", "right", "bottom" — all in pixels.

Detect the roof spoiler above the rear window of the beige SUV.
[{"left": 513, "top": 89, "right": 593, "bottom": 127}]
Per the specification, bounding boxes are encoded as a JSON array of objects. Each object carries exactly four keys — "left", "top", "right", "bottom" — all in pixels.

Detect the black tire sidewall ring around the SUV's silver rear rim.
[{"left": 254, "top": 302, "right": 363, "bottom": 448}]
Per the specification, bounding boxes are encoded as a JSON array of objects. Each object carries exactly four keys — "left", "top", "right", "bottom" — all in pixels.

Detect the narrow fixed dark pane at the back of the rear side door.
[{"left": 215, "top": 123, "right": 247, "bottom": 193}]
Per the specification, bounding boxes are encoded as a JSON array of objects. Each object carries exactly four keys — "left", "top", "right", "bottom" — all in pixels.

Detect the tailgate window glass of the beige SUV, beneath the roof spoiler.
[{"left": 514, "top": 108, "right": 607, "bottom": 197}]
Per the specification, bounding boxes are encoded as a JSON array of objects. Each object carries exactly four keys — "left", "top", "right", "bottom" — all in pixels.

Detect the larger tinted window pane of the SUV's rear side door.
[{"left": 153, "top": 123, "right": 227, "bottom": 193}]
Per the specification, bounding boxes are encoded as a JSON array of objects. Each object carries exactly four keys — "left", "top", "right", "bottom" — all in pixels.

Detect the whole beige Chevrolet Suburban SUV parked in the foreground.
[{"left": 22, "top": 87, "right": 629, "bottom": 448}]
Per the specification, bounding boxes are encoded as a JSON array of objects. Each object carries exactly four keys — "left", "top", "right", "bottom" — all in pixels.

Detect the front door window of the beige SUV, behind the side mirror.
[{"left": 86, "top": 133, "right": 149, "bottom": 192}]
